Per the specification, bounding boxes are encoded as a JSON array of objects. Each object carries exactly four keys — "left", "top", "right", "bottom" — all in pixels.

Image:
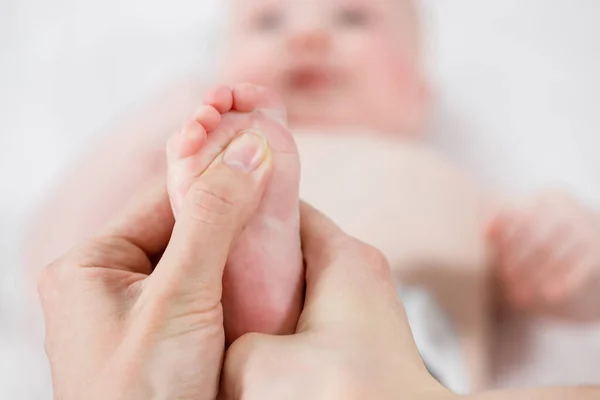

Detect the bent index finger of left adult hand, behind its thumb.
[{"left": 104, "top": 176, "right": 174, "bottom": 257}]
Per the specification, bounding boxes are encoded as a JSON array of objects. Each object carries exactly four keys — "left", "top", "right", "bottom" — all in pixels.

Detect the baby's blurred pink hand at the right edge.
[{"left": 489, "top": 194, "right": 600, "bottom": 308}]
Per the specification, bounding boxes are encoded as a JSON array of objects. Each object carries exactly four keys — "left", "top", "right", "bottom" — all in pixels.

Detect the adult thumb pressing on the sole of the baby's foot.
[{"left": 150, "top": 133, "right": 272, "bottom": 301}]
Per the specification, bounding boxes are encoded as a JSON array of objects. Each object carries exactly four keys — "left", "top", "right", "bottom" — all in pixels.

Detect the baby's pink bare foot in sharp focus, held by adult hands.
[{"left": 167, "top": 84, "right": 304, "bottom": 343}]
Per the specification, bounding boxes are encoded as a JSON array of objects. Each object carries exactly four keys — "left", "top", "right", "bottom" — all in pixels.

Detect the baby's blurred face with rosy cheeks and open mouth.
[{"left": 223, "top": 0, "right": 427, "bottom": 133}]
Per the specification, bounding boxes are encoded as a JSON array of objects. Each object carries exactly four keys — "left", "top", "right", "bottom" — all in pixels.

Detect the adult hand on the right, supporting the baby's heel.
[{"left": 222, "top": 205, "right": 454, "bottom": 400}]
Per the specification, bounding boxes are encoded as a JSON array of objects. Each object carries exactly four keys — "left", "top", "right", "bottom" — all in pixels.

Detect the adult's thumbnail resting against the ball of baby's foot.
[{"left": 223, "top": 132, "right": 267, "bottom": 172}]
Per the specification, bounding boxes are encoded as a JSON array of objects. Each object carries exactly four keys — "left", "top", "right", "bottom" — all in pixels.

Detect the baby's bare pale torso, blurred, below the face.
[{"left": 296, "top": 132, "right": 487, "bottom": 275}]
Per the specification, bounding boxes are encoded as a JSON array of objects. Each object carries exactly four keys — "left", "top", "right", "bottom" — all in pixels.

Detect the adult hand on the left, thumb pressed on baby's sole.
[{"left": 39, "top": 132, "right": 272, "bottom": 400}]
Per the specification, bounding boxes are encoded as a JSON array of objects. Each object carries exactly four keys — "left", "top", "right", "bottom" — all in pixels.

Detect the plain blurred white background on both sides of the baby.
[{"left": 0, "top": 0, "right": 600, "bottom": 400}]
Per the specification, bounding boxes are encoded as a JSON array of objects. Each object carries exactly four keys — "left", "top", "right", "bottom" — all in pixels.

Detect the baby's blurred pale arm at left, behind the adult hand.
[{"left": 25, "top": 81, "right": 203, "bottom": 277}]
